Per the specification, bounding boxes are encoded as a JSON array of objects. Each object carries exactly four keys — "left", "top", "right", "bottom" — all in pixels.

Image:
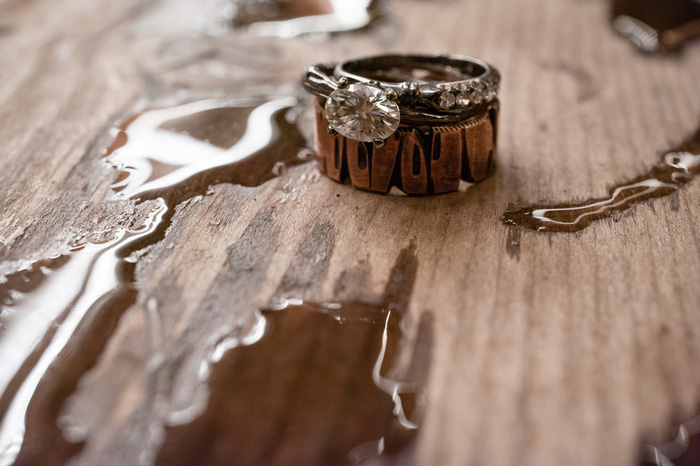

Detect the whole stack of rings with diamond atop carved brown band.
[{"left": 302, "top": 55, "right": 500, "bottom": 194}]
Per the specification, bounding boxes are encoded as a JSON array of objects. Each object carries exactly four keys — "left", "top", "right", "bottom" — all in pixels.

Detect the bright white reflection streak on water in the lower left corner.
[{"left": 0, "top": 208, "right": 167, "bottom": 466}]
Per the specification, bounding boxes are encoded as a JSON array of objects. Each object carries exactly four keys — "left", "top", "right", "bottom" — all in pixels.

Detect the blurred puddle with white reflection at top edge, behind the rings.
[{"left": 233, "top": 0, "right": 378, "bottom": 38}]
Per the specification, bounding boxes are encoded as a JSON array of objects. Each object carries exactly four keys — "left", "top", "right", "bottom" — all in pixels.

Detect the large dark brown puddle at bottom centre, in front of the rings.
[{"left": 156, "top": 300, "right": 427, "bottom": 465}]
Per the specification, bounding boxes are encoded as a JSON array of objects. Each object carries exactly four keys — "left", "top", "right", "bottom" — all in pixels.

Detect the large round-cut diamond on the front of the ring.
[{"left": 325, "top": 83, "right": 401, "bottom": 142}]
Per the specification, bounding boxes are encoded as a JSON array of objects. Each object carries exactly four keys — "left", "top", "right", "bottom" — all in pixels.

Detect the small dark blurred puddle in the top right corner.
[{"left": 612, "top": 0, "right": 700, "bottom": 52}]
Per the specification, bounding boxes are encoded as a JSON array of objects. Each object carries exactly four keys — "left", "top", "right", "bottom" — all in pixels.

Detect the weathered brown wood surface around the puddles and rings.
[{"left": 0, "top": 0, "right": 700, "bottom": 465}]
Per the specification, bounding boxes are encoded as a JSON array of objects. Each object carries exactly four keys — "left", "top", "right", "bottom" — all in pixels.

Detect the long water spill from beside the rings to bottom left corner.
[{"left": 0, "top": 97, "right": 305, "bottom": 465}]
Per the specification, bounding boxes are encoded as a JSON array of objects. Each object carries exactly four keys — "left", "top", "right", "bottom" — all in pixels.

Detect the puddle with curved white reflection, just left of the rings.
[{"left": 105, "top": 97, "right": 306, "bottom": 199}]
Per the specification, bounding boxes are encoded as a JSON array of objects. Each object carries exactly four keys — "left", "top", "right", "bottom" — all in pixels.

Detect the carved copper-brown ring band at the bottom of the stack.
[{"left": 314, "top": 100, "right": 499, "bottom": 195}]
